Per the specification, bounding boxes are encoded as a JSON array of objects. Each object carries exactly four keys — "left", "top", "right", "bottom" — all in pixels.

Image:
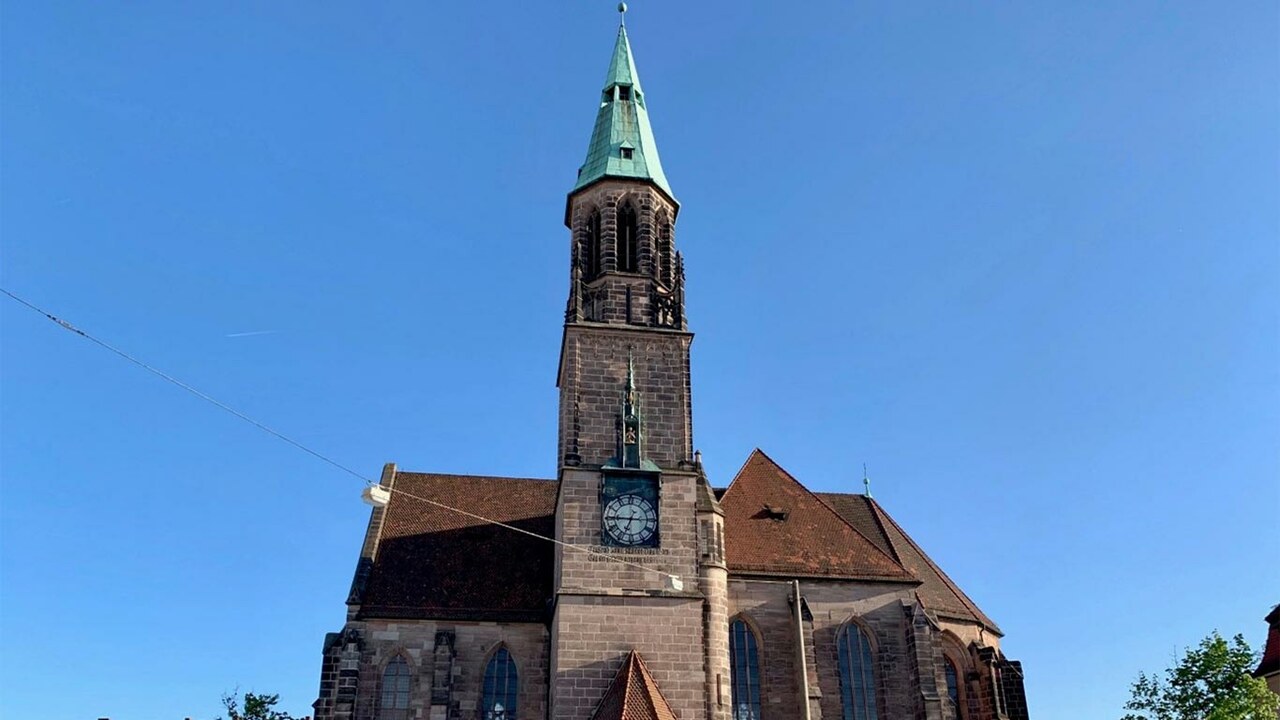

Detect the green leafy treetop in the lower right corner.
[{"left": 1124, "top": 630, "right": 1280, "bottom": 720}]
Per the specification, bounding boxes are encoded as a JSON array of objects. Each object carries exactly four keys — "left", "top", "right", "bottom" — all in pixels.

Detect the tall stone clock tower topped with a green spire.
[{"left": 549, "top": 6, "right": 728, "bottom": 720}]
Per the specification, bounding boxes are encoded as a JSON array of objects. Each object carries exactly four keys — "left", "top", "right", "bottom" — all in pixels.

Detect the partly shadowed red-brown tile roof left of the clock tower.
[{"left": 358, "top": 473, "right": 558, "bottom": 621}]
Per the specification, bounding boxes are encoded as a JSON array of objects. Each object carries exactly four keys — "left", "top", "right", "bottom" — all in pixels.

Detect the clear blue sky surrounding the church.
[{"left": 0, "top": 1, "right": 1280, "bottom": 720}]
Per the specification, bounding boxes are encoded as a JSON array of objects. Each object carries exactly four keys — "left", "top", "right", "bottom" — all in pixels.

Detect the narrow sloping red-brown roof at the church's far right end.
[{"left": 818, "top": 492, "right": 1002, "bottom": 634}]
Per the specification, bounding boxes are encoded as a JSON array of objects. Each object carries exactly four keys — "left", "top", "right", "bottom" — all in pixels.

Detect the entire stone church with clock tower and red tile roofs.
[{"left": 314, "top": 8, "right": 1028, "bottom": 720}]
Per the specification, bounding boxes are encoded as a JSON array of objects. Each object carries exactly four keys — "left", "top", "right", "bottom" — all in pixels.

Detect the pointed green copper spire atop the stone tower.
[{"left": 573, "top": 5, "right": 676, "bottom": 200}]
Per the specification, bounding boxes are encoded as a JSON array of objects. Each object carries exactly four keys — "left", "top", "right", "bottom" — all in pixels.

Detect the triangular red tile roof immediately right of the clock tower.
[{"left": 721, "top": 448, "right": 915, "bottom": 582}]
